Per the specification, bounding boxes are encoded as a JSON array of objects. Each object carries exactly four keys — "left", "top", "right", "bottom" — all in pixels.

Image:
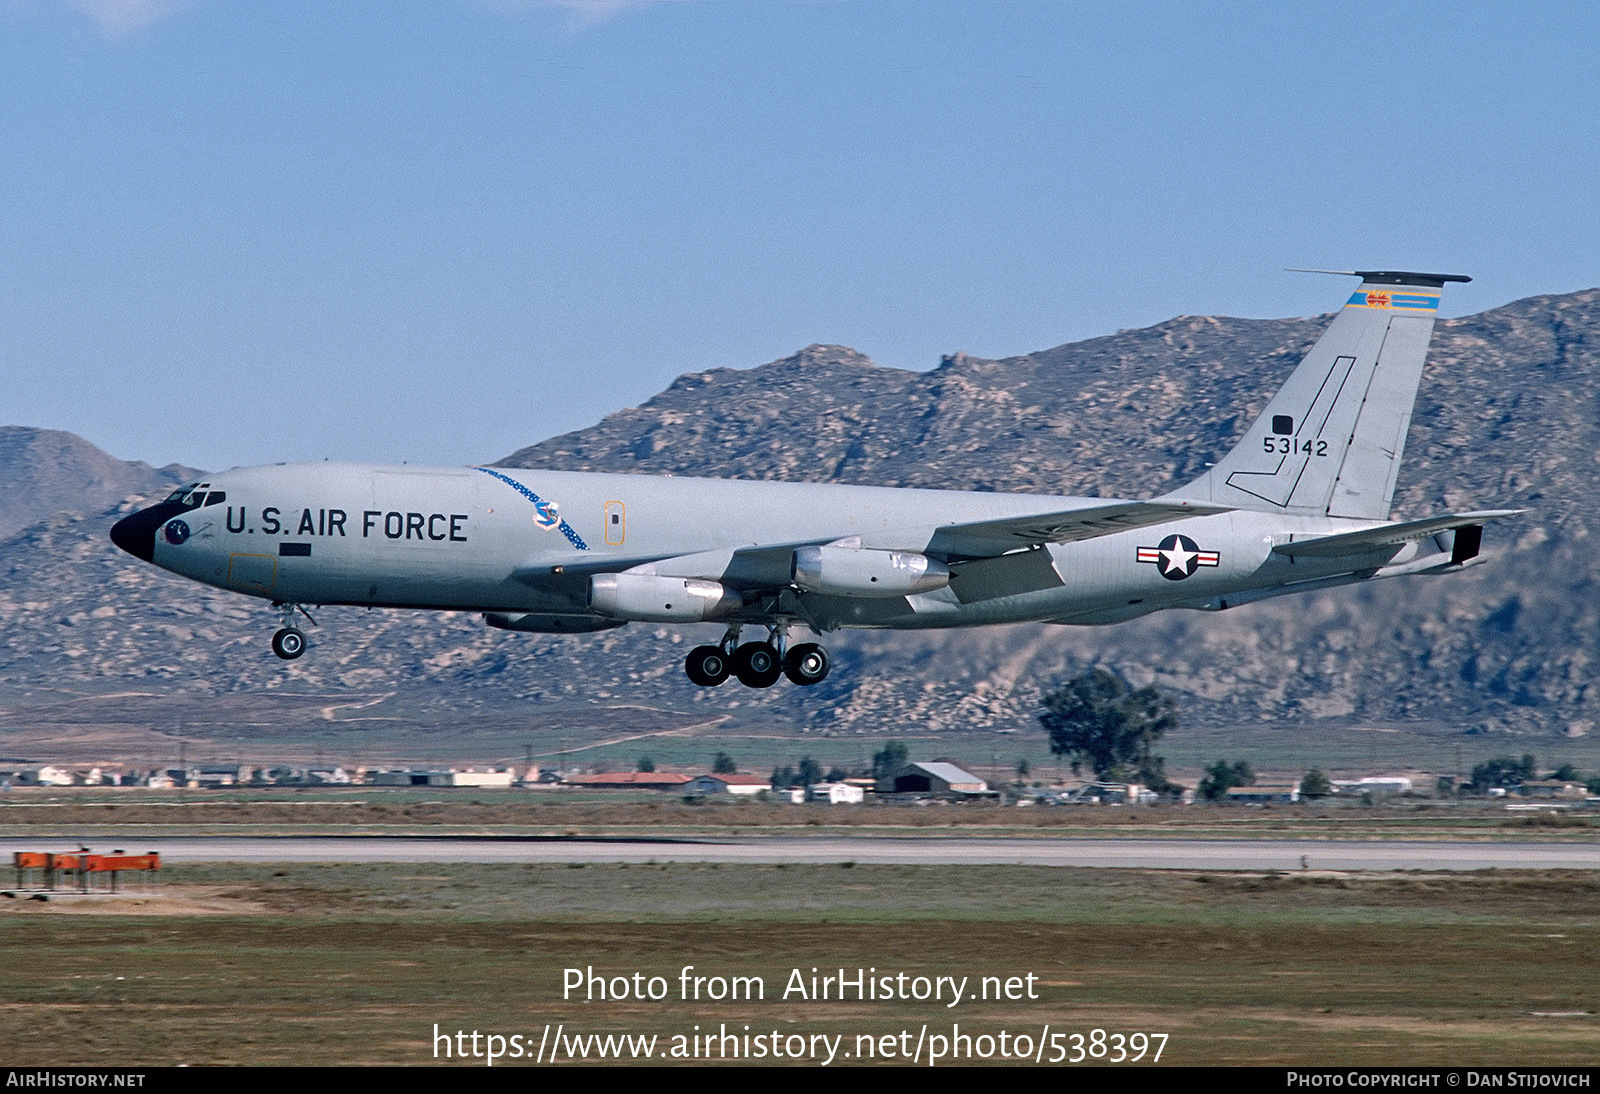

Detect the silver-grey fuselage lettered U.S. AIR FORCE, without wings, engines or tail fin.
[{"left": 116, "top": 464, "right": 1402, "bottom": 630}]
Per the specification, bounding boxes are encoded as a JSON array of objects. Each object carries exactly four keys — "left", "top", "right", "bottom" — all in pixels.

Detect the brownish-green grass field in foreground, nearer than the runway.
[{"left": 0, "top": 864, "right": 1600, "bottom": 1065}]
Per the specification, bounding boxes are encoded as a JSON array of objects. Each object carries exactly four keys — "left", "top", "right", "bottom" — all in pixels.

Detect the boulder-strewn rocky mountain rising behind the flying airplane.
[{"left": 0, "top": 289, "right": 1600, "bottom": 754}]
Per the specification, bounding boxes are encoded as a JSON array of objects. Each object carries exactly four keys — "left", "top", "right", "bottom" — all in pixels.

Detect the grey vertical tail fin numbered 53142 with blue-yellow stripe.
[{"left": 1168, "top": 270, "right": 1472, "bottom": 520}]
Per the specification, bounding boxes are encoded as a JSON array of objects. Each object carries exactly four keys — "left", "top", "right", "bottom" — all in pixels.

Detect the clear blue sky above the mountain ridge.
[{"left": 0, "top": 0, "right": 1600, "bottom": 469}]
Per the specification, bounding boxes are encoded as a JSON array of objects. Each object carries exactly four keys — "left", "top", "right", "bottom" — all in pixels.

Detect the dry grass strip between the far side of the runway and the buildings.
[{"left": 0, "top": 787, "right": 1600, "bottom": 844}]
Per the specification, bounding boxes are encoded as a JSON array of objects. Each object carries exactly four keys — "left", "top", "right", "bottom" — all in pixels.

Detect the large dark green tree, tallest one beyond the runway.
[{"left": 1038, "top": 669, "right": 1182, "bottom": 793}]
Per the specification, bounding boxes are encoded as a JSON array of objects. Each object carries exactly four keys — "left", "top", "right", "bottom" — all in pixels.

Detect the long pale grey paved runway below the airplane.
[{"left": 0, "top": 832, "right": 1600, "bottom": 872}]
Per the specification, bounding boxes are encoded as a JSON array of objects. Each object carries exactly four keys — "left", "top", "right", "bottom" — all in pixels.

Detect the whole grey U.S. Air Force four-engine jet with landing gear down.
[{"left": 110, "top": 270, "right": 1517, "bottom": 688}]
